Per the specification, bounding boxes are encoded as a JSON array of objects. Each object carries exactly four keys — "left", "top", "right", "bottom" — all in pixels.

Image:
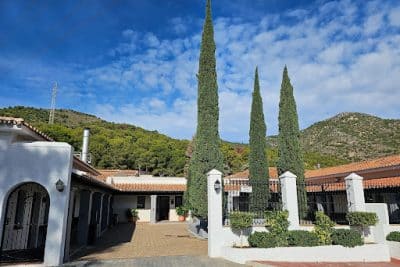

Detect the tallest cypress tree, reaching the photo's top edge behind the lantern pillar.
[{"left": 186, "top": 0, "right": 223, "bottom": 218}]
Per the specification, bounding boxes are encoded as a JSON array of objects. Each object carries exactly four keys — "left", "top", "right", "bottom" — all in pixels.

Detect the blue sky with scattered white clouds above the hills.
[{"left": 0, "top": 0, "right": 400, "bottom": 142}]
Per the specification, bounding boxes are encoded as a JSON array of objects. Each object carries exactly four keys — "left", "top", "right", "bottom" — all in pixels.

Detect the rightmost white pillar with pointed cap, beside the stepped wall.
[{"left": 344, "top": 173, "right": 365, "bottom": 214}]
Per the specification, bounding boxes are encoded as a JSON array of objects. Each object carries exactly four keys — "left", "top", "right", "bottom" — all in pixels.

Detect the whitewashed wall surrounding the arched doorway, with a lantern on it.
[{"left": 0, "top": 141, "right": 73, "bottom": 265}]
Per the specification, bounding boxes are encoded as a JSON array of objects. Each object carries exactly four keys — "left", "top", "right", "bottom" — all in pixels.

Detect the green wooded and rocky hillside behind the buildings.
[{"left": 0, "top": 107, "right": 400, "bottom": 176}]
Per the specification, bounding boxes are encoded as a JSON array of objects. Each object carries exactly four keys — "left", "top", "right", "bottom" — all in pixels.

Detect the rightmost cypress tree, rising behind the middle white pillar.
[{"left": 277, "top": 66, "right": 307, "bottom": 217}]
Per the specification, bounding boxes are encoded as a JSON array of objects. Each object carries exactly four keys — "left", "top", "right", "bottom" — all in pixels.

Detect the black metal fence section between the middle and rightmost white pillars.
[{"left": 297, "top": 181, "right": 347, "bottom": 224}]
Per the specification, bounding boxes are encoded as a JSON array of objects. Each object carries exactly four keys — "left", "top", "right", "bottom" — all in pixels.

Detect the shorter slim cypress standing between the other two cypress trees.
[{"left": 249, "top": 68, "right": 269, "bottom": 213}]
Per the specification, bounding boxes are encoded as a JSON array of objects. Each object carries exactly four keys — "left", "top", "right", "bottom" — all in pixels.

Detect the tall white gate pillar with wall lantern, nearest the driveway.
[{"left": 207, "top": 169, "right": 224, "bottom": 258}]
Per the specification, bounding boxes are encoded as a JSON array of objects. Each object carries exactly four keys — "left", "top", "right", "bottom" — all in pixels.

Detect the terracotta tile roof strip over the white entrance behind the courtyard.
[{"left": 114, "top": 184, "right": 186, "bottom": 192}]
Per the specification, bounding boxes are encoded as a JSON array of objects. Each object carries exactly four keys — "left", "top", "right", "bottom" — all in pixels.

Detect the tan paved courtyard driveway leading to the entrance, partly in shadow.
[{"left": 74, "top": 223, "right": 207, "bottom": 260}]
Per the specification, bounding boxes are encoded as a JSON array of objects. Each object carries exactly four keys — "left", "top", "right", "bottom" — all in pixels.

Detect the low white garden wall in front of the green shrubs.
[{"left": 221, "top": 245, "right": 394, "bottom": 264}]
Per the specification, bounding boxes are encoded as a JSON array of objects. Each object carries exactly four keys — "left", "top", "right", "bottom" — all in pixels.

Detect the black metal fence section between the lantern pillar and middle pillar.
[{"left": 224, "top": 179, "right": 282, "bottom": 225}]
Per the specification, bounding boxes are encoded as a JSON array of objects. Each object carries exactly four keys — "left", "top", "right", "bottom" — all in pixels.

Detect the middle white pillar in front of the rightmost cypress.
[{"left": 279, "top": 171, "right": 300, "bottom": 230}]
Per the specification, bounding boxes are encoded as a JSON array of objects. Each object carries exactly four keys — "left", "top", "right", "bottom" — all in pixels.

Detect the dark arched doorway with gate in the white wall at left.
[{"left": 0, "top": 182, "right": 50, "bottom": 262}]
